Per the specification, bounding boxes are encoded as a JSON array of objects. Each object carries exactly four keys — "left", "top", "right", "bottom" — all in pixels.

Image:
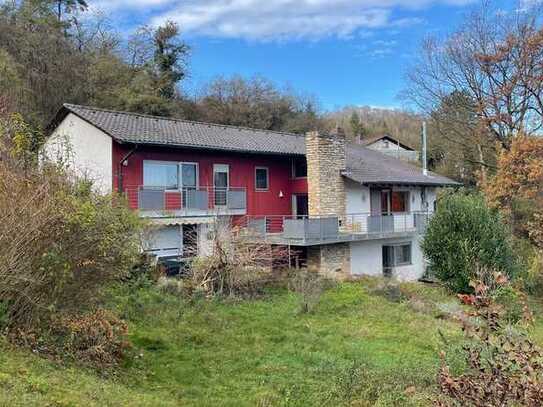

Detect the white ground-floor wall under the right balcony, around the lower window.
[{"left": 350, "top": 235, "right": 425, "bottom": 281}]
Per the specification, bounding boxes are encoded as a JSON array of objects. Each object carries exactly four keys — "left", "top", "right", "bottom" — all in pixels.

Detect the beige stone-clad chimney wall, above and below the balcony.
[{"left": 306, "top": 129, "right": 351, "bottom": 278}]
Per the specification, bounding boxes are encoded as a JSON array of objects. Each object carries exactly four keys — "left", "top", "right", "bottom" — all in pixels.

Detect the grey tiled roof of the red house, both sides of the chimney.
[{"left": 49, "top": 104, "right": 459, "bottom": 186}]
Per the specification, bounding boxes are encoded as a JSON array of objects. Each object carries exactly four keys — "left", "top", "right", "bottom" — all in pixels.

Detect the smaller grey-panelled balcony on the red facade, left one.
[{"left": 125, "top": 185, "right": 247, "bottom": 217}]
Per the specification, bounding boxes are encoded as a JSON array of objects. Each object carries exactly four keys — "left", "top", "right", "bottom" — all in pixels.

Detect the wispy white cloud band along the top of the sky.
[{"left": 97, "top": 0, "right": 474, "bottom": 40}]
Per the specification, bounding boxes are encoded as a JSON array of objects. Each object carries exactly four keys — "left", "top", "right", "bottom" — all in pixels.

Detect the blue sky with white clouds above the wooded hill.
[{"left": 91, "top": 0, "right": 528, "bottom": 109}]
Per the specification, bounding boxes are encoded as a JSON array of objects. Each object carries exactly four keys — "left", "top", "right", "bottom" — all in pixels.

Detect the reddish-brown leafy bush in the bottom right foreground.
[{"left": 435, "top": 272, "right": 543, "bottom": 407}]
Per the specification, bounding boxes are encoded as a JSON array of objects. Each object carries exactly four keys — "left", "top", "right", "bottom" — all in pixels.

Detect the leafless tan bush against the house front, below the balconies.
[{"left": 191, "top": 219, "right": 288, "bottom": 296}]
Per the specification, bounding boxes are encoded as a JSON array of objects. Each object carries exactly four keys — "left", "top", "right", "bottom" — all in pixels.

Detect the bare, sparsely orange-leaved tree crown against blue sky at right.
[{"left": 406, "top": 3, "right": 543, "bottom": 148}]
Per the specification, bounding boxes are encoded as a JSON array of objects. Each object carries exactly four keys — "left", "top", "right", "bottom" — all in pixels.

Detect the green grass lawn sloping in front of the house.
[{"left": 0, "top": 280, "right": 543, "bottom": 407}]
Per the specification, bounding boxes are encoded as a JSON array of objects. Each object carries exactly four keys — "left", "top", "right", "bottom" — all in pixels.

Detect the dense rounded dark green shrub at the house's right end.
[{"left": 422, "top": 192, "right": 517, "bottom": 292}]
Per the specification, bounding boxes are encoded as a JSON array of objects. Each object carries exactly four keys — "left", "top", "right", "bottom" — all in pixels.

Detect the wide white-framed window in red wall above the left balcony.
[{"left": 143, "top": 161, "right": 198, "bottom": 189}]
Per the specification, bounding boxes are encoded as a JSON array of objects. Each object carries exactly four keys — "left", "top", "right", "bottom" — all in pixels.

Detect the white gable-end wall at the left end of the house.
[{"left": 44, "top": 113, "right": 113, "bottom": 193}]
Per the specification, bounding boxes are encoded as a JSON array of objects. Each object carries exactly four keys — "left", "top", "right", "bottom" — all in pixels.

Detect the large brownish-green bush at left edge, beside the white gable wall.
[{"left": 0, "top": 162, "right": 140, "bottom": 326}]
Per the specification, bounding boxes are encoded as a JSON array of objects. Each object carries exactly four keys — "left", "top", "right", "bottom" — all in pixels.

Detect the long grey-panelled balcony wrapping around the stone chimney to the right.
[{"left": 238, "top": 212, "right": 431, "bottom": 246}]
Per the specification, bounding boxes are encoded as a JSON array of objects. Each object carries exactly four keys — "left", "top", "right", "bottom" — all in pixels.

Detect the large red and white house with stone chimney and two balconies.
[{"left": 45, "top": 104, "right": 457, "bottom": 280}]
